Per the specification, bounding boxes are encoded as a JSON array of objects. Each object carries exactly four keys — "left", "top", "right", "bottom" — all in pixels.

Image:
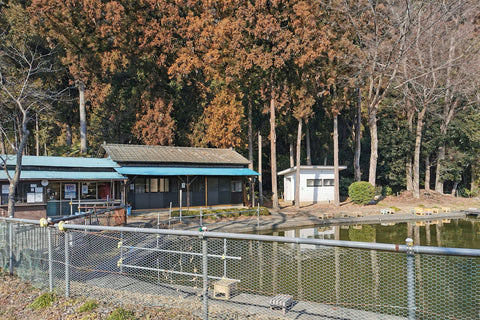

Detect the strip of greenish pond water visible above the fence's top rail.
[{"left": 269, "top": 219, "right": 480, "bottom": 249}]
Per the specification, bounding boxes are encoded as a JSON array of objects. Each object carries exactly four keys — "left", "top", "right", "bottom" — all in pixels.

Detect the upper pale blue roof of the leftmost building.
[{"left": 0, "top": 155, "right": 118, "bottom": 168}]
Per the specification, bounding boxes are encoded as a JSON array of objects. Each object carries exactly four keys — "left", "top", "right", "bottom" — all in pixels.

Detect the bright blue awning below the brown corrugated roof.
[{"left": 115, "top": 167, "right": 259, "bottom": 176}]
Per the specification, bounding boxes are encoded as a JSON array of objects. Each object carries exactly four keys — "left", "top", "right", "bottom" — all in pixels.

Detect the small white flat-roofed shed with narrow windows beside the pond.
[{"left": 278, "top": 166, "right": 347, "bottom": 203}]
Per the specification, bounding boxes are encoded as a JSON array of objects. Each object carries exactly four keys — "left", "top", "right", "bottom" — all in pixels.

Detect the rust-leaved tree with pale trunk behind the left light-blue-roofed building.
[{"left": 29, "top": 0, "right": 126, "bottom": 153}]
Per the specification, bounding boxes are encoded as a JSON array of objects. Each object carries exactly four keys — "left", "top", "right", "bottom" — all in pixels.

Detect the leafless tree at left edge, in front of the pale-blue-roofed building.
[{"left": 0, "top": 39, "right": 55, "bottom": 216}]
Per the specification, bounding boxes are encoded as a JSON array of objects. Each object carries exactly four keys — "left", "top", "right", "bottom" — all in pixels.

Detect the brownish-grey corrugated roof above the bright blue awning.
[{"left": 102, "top": 144, "right": 249, "bottom": 165}]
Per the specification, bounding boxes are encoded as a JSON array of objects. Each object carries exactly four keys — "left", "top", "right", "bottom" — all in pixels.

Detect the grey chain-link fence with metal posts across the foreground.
[{"left": 0, "top": 219, "right": 480, "bottom": 319}]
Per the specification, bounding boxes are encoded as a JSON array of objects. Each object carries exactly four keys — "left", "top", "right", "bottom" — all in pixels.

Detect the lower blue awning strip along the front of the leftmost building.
[{"left": 0, "top": 170, "right": 126, "bottom": 180}]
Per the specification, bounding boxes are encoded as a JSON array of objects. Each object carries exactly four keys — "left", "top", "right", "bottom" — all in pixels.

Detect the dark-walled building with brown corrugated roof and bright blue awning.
[{"left": 102, "top": 144, "right": 258, "bottom": 209}]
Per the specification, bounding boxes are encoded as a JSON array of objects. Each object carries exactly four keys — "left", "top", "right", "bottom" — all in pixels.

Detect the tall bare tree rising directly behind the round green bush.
[{"left": 343, "top": 0, "right": 414, "bottom": 185}]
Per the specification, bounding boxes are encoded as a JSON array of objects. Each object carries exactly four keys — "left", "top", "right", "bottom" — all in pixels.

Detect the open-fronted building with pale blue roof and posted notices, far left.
[{"left": 0, "top": 155, "right": 126, "bottom": 218}]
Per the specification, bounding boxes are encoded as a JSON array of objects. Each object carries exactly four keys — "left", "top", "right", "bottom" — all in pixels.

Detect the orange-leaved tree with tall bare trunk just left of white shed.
[{"left": 227, "top": 1, "right": 329, "bottom": 208}]
